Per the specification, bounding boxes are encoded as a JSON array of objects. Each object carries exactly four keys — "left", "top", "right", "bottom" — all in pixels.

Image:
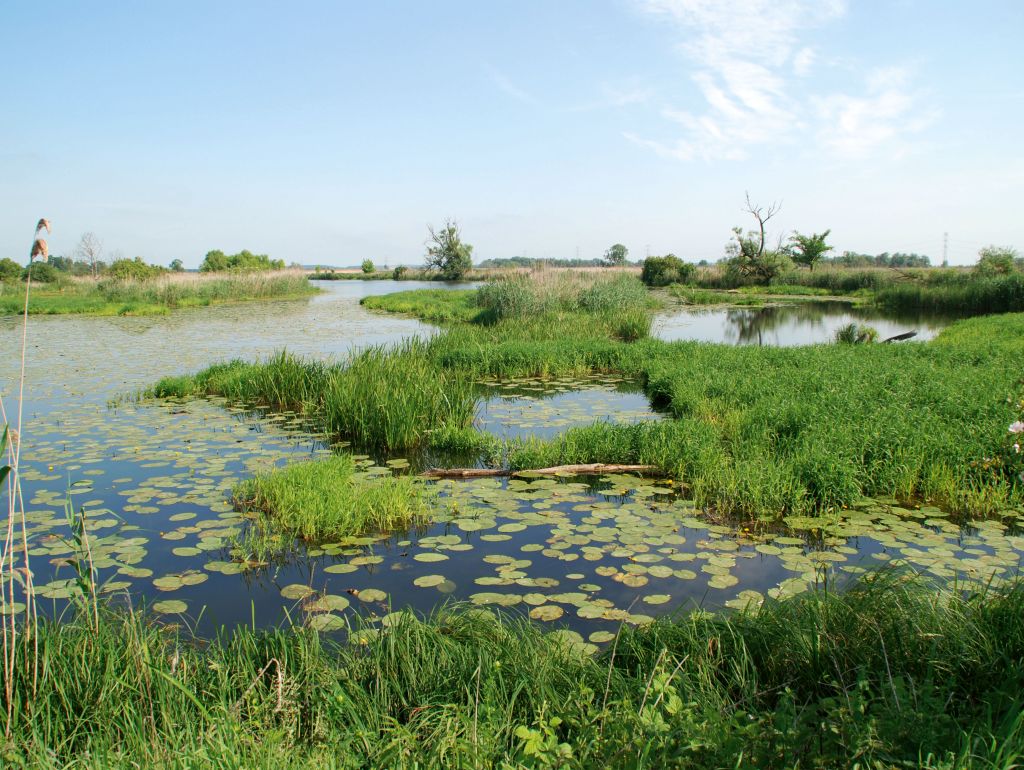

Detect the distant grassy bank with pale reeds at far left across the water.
[{"left": 0, "top": 271, "right": 317, "bottom": 315}]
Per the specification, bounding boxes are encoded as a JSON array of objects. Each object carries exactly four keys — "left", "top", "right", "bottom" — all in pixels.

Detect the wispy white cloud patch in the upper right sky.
[{"left": 627, "top": 0, "right": 922, "bottom": 161}]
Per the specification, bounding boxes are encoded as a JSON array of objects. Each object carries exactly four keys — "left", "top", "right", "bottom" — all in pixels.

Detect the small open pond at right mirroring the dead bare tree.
[{"left": 652, "top": 301, "right": 949, "bottom": 347}]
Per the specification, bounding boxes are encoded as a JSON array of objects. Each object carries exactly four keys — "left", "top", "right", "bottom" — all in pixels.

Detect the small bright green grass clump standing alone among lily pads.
[{"left": 232, "top": 455, "right": 428, "bottom": 542}]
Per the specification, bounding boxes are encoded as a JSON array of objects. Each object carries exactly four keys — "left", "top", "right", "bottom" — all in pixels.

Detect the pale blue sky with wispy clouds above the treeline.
[{"left": 0, "top": 0, "right": 1024, "bottom": 267}]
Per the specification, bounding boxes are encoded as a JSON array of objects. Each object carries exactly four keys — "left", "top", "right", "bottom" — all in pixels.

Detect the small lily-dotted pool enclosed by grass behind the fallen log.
[{"left": 474, "top": 377, "right": 662, "bottom": 438}]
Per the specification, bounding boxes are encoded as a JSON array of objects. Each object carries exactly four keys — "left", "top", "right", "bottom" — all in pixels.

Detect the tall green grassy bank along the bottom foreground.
[{"left": 9, "top": 574, "right": 1024, "bottom": 770}]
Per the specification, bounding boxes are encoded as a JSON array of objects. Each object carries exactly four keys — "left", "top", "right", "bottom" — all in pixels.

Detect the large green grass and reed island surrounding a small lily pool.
[{"left": 152, "top": 268, "right": 1024, "bottom": 520}]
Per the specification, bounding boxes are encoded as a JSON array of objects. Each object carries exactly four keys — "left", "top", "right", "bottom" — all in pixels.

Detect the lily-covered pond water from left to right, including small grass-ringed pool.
[{"left": 0, "top": 282, "right": 1024, "bottom": 643}]
